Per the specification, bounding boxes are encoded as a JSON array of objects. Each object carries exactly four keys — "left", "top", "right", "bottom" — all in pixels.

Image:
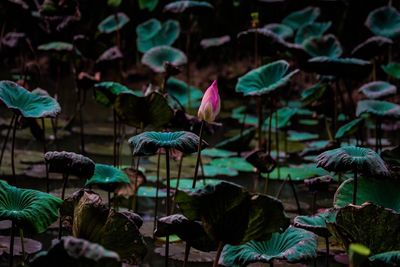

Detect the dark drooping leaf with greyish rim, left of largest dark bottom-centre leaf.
[{"left": 154, "top": 214, "right": 218, "bottom": 252}]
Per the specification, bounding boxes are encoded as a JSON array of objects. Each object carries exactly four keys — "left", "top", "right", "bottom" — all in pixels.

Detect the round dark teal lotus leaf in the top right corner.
[{"left": 365, "top": 6, "right": 400, "bottom": 39}]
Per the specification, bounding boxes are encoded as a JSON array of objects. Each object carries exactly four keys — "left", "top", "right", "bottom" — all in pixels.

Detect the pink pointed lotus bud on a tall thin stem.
[{"left": 197, "top": 81, "right": 221, "bottom": 122}]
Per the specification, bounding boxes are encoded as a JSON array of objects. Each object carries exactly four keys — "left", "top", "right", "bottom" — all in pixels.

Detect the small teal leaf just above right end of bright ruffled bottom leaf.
[{"left": 293, "top": 210, "right": 335, "bottom": 237}]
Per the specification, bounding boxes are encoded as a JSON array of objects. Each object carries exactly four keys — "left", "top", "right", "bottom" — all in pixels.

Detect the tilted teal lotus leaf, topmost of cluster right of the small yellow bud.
[{"left": 282, "top": 6, "right": 321, "bottom": 30}]
